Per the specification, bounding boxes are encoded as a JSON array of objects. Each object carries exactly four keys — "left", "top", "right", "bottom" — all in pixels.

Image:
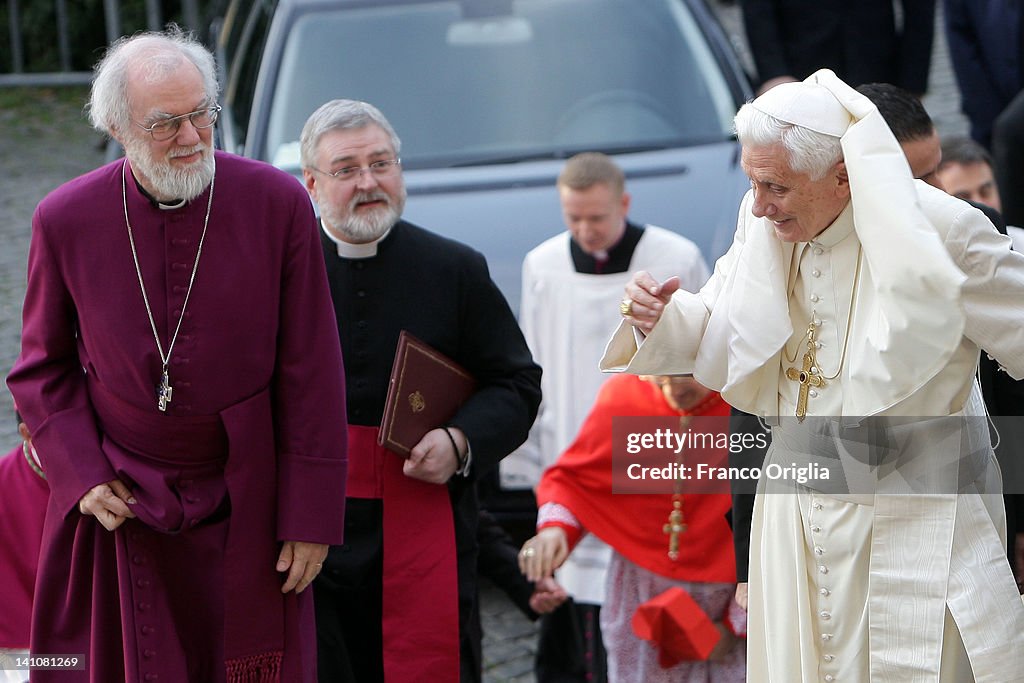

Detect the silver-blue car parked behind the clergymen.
[{"left": 211, "top": 0, "right": 751, "bottom": 308}]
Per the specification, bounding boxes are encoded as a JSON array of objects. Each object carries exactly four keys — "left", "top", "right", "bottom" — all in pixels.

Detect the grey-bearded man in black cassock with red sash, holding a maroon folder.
[{"left": 301, "top": 99, "right": 541, "bottom": 683}]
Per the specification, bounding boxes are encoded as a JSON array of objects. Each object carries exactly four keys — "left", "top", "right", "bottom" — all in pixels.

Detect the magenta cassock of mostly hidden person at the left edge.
[{"left": 0, "top": 445, "right": 50, "bottom": 650}]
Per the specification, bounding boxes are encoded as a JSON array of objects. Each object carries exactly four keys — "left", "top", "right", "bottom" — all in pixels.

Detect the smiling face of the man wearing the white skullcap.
[{"left": 741, "top": 144, "right": 850, "bottom": 242}]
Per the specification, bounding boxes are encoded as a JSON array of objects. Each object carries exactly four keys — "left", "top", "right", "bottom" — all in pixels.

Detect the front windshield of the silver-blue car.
[{"left": 262, "top": 0, "right": 735, "bottom": 169}]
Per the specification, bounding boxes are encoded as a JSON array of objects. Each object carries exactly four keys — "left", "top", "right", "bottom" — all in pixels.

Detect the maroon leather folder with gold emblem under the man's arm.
[{"left": 377, "top": 330, "right": 476, "bottom": 458}]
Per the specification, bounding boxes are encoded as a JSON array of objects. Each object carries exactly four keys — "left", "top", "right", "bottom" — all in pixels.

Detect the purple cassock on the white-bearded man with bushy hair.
[{"left": 7, "top": 153, "right": 346, "bottom": 683}]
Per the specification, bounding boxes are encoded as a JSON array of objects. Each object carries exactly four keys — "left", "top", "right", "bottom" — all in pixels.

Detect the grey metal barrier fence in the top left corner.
[{"left": 0, "top": 0, "right": 202, "bottom": 87}]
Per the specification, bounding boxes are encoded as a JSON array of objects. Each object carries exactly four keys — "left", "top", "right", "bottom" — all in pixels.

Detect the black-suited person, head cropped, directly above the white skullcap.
[{"left": 739, "top": 0, "right": 937, "bottom": 94}]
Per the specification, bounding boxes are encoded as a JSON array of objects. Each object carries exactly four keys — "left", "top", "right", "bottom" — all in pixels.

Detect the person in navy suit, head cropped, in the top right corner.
[{"left": 943, "top": 0, "right": 1024, "bottom": 148}]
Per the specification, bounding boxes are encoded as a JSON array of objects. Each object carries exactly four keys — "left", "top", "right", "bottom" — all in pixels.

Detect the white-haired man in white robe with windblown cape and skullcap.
[{"left": 602, "top": 70, "right": 1024, "bottom": 683}]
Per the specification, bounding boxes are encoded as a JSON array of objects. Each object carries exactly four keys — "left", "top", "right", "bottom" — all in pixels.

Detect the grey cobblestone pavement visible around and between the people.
[{"left": 0, "top": 0, "right": 967, "bottom": 683}]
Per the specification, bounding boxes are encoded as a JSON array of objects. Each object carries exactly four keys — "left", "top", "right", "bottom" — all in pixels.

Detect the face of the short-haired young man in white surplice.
[{"left": 558, "top": 182, "right": 630, "bottom": 254}]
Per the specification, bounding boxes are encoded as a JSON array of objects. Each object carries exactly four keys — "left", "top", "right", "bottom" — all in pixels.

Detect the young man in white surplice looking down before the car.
[{"left": 501, "top": 153, "right": 709, "bottom": 683}]
